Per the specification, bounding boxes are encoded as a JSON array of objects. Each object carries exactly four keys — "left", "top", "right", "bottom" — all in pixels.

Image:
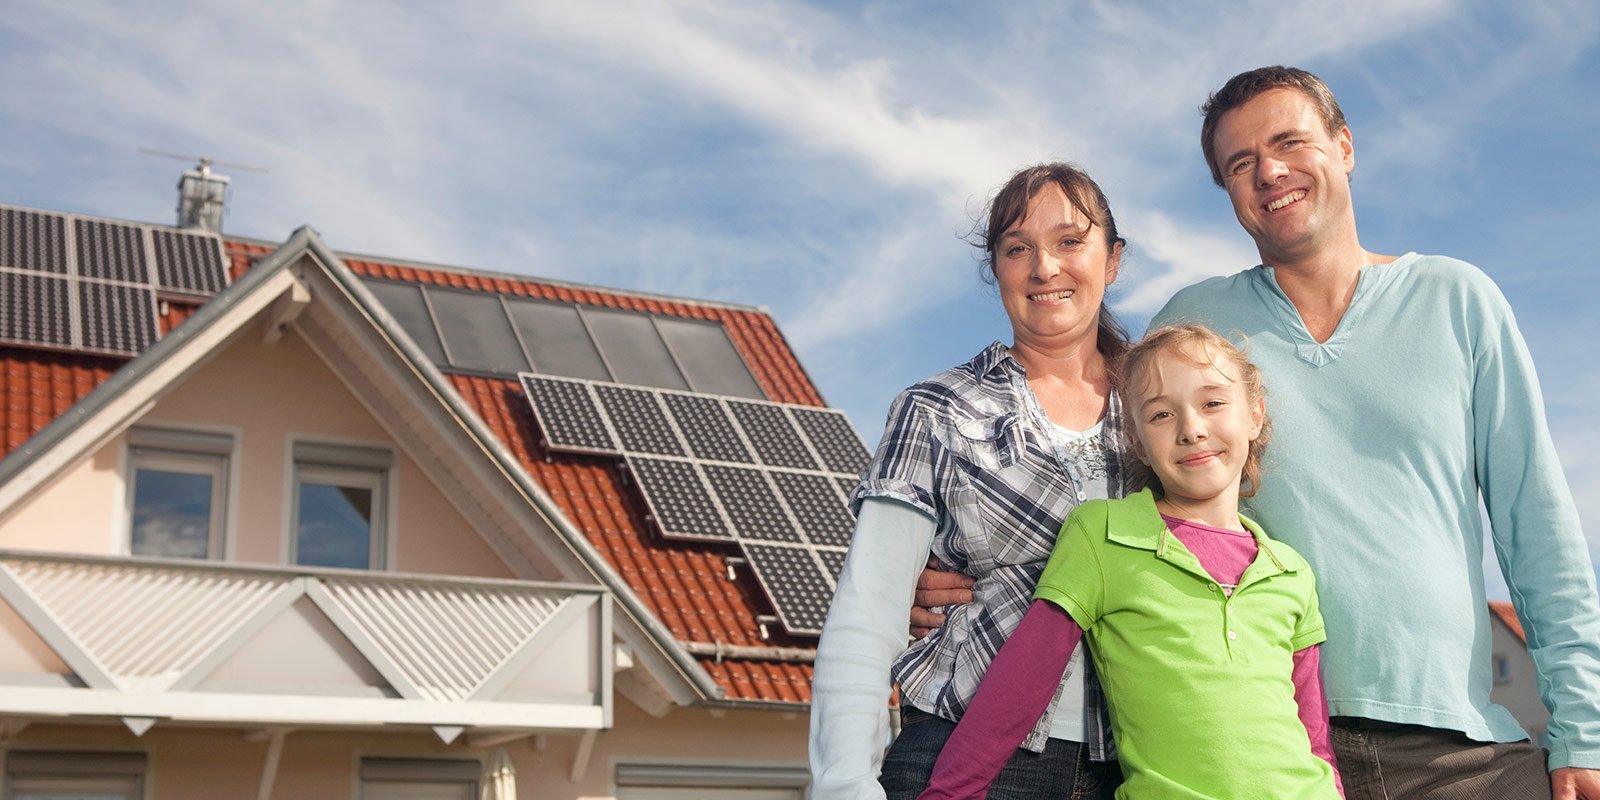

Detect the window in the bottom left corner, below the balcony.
[{"left": 5, "top": 752, "right": 146, "bottom": 800}]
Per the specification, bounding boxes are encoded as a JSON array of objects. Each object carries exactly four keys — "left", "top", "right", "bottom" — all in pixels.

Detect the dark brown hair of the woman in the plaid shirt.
[{"left": 968, "top": 162, "right": 1128, "bottom": 362}]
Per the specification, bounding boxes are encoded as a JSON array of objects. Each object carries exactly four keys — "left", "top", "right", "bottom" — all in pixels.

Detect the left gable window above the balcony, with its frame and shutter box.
[{"left": 128, "top": 427, "right": 234, "bottom": 558}]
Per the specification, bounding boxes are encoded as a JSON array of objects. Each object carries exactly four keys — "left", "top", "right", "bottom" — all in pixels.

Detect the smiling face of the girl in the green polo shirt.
[{"left": 1134, "top": 347, "right": 1266, "bottom": 507}]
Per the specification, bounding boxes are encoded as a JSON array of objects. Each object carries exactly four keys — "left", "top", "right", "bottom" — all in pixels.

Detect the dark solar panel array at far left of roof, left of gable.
[{"left": 0, "top": 206, "right": 227, "bottom": 355}]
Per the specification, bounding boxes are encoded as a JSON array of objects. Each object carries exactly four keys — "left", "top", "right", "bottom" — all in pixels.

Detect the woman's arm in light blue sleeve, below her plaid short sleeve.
[{"left": 810, "top": 498, "right": 934, "bottom": 800}]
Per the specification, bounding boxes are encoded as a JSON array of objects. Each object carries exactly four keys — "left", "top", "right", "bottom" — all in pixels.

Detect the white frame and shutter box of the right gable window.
[{"left": 285, "top": 440, "right": 395, "bottom": 571}]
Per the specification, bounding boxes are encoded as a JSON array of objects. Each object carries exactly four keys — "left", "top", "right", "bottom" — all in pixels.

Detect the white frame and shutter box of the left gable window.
[{"left": 123, "top": 427, "right": 237, "bottom": 560}]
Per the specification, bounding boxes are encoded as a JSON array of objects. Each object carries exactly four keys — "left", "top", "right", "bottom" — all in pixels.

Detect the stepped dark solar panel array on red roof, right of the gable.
[{"left": 522, "top": 373, "right": 869, "bottom": 635}]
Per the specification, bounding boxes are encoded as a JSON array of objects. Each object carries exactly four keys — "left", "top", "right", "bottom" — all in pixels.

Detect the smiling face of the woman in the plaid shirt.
[{"left": 994, "top": 184, "right": 1122, "bottom": 358}]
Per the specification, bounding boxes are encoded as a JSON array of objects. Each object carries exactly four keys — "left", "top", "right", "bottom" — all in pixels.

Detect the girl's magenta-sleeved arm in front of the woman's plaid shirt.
[{"left": 917, "top": 600, "right": 1083, "bottom": 800}]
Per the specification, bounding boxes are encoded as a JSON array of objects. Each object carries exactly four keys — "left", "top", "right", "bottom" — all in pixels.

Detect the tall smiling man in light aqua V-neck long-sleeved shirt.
[{"left": 918, "top": 67, "right": 1600, "bottom": 800}]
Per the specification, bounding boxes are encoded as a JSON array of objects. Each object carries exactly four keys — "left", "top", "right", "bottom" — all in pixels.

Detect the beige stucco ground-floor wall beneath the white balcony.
[{"left": 6, "top": 699, "right": 806, "bottom": 800}]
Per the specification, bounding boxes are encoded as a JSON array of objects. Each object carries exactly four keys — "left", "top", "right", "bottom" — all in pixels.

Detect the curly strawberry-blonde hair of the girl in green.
[{"left": 1112, "top": 325, "right": 1272, "bottom": 498}]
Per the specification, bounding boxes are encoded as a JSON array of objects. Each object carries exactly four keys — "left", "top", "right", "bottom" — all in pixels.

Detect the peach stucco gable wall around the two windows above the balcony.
[{"left": 0, "top": 333, "right": 512, "bottom": 578}]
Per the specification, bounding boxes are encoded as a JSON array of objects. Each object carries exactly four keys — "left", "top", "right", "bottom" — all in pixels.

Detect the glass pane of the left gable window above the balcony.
[{"left": 131, "top": 469, "right": 214, "bottom": 558}]
